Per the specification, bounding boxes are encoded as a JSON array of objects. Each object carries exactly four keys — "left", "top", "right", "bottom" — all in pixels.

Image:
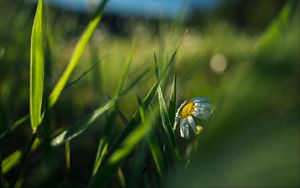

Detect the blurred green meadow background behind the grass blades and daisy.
[{"left": 0, "top": 0, "right": 300, "bottom": 187}]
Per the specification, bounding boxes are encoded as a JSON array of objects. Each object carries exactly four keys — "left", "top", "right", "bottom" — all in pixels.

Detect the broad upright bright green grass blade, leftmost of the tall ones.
[{"left": 29, "top": 0, "right": 44, "bottom": 132}]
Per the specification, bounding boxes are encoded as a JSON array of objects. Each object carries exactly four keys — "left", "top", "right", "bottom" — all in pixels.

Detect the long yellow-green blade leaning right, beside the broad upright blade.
[{"left": 49, "top": 0, "right": 107, "bottom": 107}]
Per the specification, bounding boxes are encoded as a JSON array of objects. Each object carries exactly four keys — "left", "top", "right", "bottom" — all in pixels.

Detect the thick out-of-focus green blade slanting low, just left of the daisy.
[{"left": 90, "top": 106, "right": 152, "bottom": 187}]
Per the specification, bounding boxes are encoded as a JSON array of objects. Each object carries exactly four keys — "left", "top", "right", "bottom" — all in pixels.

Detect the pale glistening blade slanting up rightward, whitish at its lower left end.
[{"left": 51, "top": 67, "right": 148, "bottom": 146}]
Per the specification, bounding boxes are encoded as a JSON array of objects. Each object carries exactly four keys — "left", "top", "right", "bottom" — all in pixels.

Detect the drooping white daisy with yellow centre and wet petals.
[{"left": 175, "top": 97, "right": 213, "bottom": 139}]
